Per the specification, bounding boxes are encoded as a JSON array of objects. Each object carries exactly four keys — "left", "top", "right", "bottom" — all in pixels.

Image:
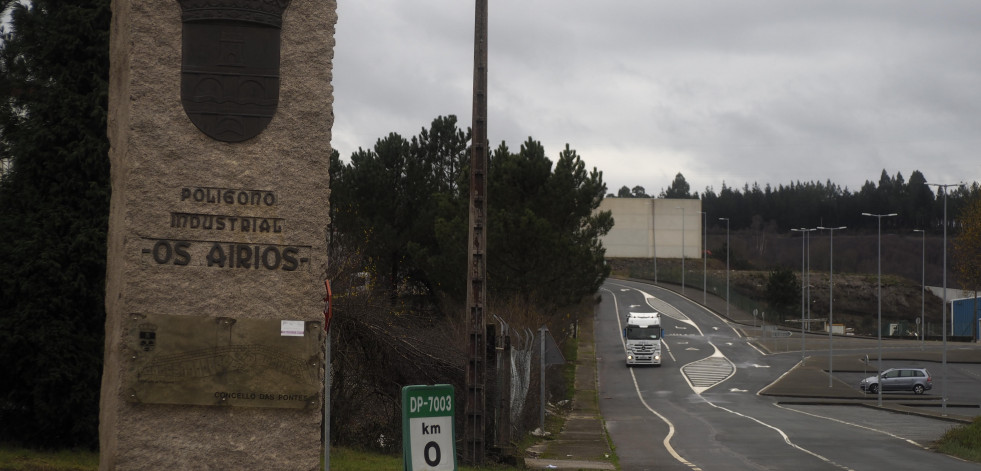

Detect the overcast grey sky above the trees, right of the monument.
[{"left": 332, "top": 0, "right": 981, "bottom": 194}]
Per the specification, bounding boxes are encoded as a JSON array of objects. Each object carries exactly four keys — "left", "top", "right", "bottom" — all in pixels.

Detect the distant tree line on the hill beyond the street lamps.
[{"left": 620, "top": 170, "right": 981, "bottom": 316}]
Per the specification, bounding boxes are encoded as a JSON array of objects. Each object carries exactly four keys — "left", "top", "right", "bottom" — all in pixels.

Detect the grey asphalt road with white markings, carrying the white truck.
[{"left": 595, "top": 280, "right": 981, "bottom": 471}]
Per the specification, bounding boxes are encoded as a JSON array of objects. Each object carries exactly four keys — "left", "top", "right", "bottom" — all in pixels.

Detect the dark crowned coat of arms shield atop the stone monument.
[{"left": 177, "top": 0, "right": 290, "bottom": 142}]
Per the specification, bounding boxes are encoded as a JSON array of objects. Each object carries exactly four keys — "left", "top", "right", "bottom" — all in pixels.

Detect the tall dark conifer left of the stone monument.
[{"left": 0, "top": 0, "right": 111, "bottom": 446}]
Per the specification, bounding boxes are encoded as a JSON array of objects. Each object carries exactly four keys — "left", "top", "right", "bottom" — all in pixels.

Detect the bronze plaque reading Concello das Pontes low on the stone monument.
[{"left": 126, "top": 314, "right": 323, "bottom": 409}]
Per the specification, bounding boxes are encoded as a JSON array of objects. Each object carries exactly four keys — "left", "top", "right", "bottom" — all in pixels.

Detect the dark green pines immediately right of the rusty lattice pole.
[{"left": 487, "top": 138, "right": 613, "bottom": 307}]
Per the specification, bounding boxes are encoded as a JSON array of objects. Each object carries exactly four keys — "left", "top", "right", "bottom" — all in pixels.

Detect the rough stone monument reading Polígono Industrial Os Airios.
[{"left": 99, "top": 0, "right": 337, "bottom": 470}]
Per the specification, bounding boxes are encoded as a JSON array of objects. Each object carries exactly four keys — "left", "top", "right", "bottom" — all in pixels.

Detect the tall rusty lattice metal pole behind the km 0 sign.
[{"left": 464, "top": 0, "right": 488, "bottom": 464}]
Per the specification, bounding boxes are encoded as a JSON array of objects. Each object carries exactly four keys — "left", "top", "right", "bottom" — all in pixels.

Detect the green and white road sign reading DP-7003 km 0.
[{"left": 402, "top": 384, "right": 456, "bottom": 471}]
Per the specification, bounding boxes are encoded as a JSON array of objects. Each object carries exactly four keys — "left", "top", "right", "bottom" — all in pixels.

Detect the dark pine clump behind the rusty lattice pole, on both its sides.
[{"left": 330, "top": 115, "right": 613, "bottom": 309}]
